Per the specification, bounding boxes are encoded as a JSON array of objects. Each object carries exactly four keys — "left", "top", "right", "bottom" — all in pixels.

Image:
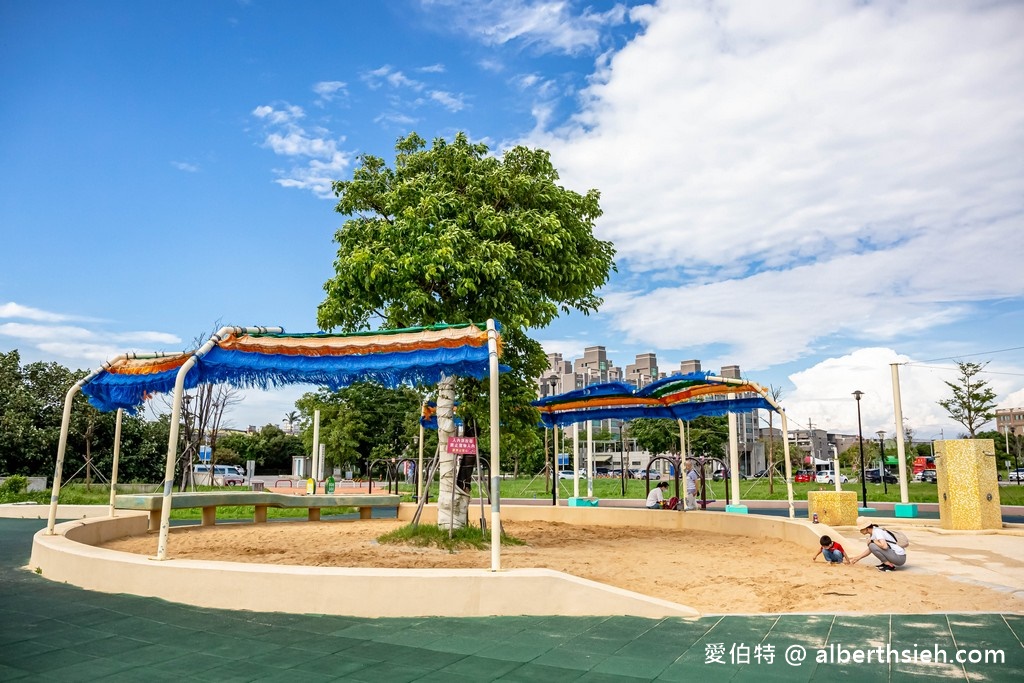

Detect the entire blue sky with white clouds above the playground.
[{"left": 0, "top": 0, "right": 1024, "bottom": 437}]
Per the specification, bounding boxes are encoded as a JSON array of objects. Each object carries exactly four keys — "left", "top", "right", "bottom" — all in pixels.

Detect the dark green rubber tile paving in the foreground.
[{"left": 0, "top": 519, "right": 1024, "bottom": 683}]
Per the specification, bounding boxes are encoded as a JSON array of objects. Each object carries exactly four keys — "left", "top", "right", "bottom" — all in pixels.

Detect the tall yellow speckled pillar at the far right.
[{"left": 935, "top": 438, "right": 1002, "bottom": 529}]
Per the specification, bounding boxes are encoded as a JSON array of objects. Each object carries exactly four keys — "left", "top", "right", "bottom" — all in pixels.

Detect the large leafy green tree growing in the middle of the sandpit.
[{"left": 317, "top": 133, "right": 614, "bottom": 526}]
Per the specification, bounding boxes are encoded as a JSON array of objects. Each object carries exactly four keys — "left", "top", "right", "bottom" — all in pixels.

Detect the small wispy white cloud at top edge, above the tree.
[{"left": 424, "top": 0, "right": 627, "bottom": 54}]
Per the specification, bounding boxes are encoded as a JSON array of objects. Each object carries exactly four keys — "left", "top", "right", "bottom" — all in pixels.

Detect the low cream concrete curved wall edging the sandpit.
[{"left": 28, "top": 505, "right": 828, "bottom": 617}]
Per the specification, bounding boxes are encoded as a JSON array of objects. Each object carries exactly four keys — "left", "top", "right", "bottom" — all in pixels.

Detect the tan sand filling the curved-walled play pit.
[{"left": 94, "top": 520, "right": 1024, "bottom": 614}]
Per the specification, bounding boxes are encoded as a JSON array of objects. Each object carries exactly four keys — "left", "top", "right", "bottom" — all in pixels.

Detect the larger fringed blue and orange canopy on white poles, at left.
[{"left": 46, "top": 319, "right": 501, "bottom": 571}]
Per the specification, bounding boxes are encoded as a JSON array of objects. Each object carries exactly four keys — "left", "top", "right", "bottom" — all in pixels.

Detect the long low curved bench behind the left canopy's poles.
[{"left": 114, "top": 490, "right": 401, "bottom": 529}]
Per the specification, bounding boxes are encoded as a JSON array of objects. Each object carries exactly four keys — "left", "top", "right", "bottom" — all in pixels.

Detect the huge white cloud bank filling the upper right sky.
[{"left": 527, "top": 0, "right": 1024, "bottom": 369}]
